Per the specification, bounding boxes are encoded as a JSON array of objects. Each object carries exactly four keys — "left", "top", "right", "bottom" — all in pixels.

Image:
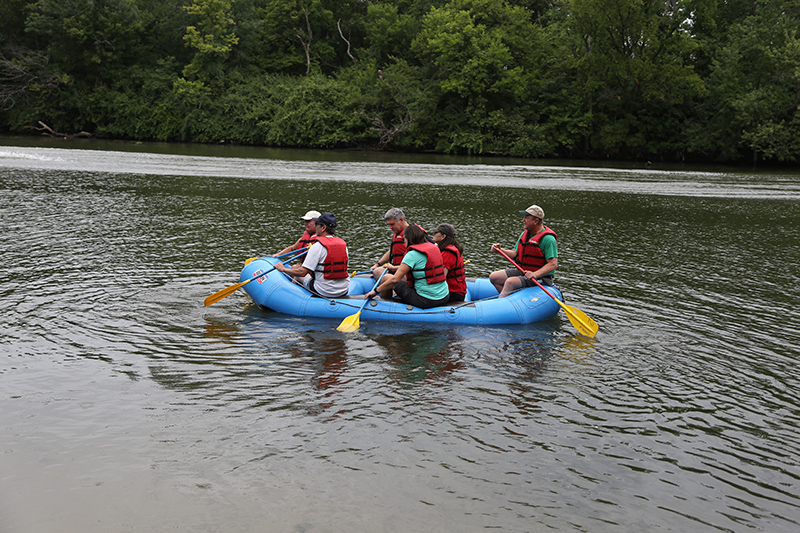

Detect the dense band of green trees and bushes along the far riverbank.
[{"left": 0, "top": 0, "right": 800, "bottom": 162}]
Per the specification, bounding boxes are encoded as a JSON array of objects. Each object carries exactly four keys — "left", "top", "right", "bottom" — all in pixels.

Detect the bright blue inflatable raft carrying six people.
[{"left": 239, "top": 257, "right": 562, "bottom": 325}]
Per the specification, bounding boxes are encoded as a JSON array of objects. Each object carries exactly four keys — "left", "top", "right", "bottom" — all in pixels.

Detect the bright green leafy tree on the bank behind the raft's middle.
[{"left": 412, "top": 0, "right": 541, "bottom": 154}]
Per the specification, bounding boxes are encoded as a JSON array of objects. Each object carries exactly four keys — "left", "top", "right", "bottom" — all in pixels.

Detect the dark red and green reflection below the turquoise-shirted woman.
[{"left": 372, "top": 330, "right": 464, "bottom": 385}]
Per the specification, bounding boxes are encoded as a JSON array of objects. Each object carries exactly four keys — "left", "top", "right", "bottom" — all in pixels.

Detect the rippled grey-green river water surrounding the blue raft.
[{"left": 0, "top": 138, "right": 800, "bottom": 533}]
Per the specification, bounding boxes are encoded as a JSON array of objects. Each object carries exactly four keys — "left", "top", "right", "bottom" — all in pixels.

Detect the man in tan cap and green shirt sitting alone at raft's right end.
[{"left": 489, "top": 205, "right": 558, "bottom": 298}]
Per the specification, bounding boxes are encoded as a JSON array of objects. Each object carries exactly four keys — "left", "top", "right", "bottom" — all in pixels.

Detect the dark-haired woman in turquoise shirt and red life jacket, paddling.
[{"left": 367, "top": 224, "right": 450, "bottom": 309}]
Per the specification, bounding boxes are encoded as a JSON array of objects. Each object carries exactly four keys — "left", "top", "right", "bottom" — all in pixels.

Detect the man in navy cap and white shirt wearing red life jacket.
[{"left": 275, "top": 213, "right": 350, "bottom": 298}]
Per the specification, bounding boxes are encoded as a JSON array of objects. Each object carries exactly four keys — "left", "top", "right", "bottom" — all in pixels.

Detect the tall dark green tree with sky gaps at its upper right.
[{"left": 561, "top": 0, "right": 704, "bottom": 156}]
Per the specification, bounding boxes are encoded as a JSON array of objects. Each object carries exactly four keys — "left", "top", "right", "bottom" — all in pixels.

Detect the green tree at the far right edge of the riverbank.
[{"left": 698, "top": 2, "right": 800, "bottom": 161}]
